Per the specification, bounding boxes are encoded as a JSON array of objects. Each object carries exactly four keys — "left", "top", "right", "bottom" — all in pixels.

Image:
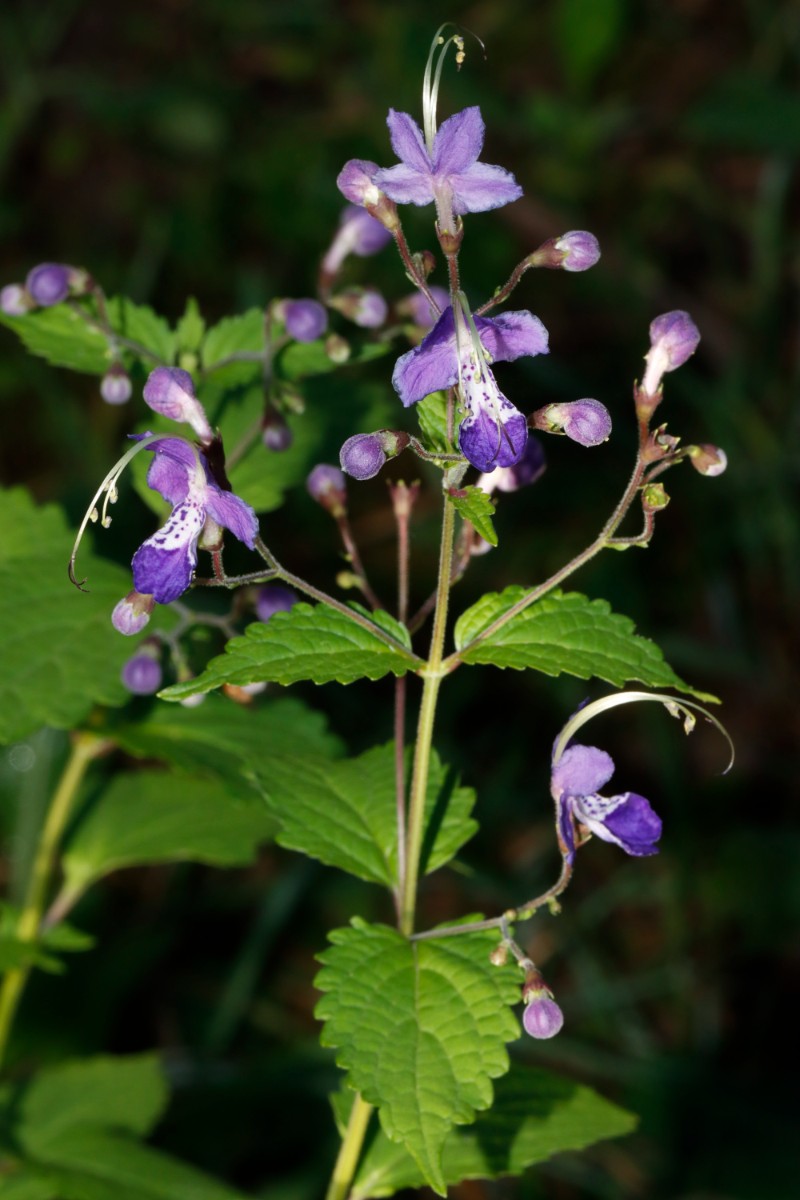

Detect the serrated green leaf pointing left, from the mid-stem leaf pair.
[{"left": 161, "top": 604, "right": 420, "bottom": 700}]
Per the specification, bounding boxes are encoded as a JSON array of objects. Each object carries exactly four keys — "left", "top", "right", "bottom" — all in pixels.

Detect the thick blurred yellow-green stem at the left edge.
[{"left": 0, "top": 733, "right": 108, "bottom": 1064}]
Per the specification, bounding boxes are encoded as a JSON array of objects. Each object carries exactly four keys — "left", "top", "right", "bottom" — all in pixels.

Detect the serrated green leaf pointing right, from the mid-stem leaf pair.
[{"left": 455, "top": 586, "right": 715, "bottom": 701}]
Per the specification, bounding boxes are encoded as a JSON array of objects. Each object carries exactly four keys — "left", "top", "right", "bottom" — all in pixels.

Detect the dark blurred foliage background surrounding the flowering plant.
[{"left": 0, "top": 0, "right": 800, "bottom": 1200}]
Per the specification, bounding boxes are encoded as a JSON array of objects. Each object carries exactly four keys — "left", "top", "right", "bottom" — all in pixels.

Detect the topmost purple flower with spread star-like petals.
[{"left": 373, "top": 106, "right": 522, "bottom": 230}]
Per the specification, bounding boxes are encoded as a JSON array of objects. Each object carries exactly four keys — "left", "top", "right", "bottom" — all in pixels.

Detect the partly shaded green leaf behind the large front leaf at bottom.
[{"left": 335, "top": 1063, "right": 637, "bottom": 1200}]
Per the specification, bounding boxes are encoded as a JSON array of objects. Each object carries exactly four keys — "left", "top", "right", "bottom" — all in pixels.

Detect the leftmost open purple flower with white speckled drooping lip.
[{"left": 132, "top": 438, "right": 258, "bottom": 604}]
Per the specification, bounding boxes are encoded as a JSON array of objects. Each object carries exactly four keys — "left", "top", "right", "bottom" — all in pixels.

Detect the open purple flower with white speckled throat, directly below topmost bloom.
[{"left": 392, "top": 302, "right": 547, "bottom": 472}]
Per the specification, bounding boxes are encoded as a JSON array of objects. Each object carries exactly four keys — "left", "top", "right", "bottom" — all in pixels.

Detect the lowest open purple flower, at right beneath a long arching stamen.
[{"left": 551, "top": 745, "right": 661, "bottom": 863}]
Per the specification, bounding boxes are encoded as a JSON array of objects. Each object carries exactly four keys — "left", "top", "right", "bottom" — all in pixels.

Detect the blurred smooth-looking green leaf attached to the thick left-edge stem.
[{"left": 64, "top": 770, "right": 275, "bottom": 893}]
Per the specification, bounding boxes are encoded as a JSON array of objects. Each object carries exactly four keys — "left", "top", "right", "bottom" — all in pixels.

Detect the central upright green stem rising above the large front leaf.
[{"left": 399, "top": 494, "right": 456, "bottom": 937}]
